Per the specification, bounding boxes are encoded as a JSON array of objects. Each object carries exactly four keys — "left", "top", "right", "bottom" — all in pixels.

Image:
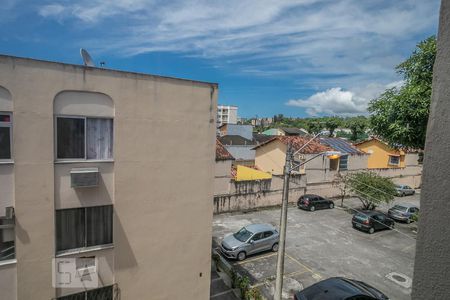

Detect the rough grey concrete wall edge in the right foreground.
[{"left": 412, "top": 0, "right": 450, "bottom": 300}]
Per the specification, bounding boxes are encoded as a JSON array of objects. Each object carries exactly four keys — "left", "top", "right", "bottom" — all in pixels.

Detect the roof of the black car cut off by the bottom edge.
[{"left": 297, "top": 277, "right": 380, "bottom": 300}]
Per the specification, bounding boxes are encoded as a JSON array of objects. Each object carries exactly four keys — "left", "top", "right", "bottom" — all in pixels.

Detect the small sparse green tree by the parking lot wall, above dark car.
[{"left": 347, "top": 171, "right": 396, "bottom": 210}]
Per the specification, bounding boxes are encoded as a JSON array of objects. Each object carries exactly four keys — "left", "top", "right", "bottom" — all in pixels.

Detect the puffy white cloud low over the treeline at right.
[{"left": 286, "top": 81, "right": 403, "bottom": 116}]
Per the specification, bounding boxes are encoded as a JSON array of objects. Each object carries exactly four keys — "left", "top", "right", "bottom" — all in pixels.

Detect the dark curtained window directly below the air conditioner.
[{"left": 56, "top": 205, "right": 113, "bottom": 251}]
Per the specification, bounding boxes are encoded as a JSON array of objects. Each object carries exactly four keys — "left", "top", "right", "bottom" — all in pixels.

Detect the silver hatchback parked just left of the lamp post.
[{"left": 220, "top": 224, "right": 280, "bottom": 260}]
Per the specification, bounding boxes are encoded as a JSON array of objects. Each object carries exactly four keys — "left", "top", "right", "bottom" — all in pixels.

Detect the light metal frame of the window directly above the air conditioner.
[{"left": 53, "top": 114, "right": 115, "bottom": 163}]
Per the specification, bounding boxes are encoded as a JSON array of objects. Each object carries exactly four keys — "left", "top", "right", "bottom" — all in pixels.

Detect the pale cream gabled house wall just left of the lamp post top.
[{"left": 255, "top": 140, "right": 287, "bottom": 175}]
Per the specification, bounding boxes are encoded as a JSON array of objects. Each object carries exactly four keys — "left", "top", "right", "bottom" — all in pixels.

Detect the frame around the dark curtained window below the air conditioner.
[{"left": 55, "top": 204, "right": 114, "bottom": 256}]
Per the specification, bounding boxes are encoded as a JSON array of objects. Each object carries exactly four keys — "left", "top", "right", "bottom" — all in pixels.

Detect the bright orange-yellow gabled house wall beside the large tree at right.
[{"left": 356, "top": 140, "right": 405, "bottom": 169}]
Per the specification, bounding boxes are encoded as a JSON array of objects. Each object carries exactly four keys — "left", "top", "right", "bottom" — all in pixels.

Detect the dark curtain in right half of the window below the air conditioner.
[{"left": 86, "top": 205, "right": 113, "bottom": 247}]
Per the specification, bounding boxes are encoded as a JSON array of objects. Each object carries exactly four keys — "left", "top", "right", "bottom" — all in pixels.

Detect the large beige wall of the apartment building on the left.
[{"left": 0, "top": 56, "right": 217, "bottom": 300}]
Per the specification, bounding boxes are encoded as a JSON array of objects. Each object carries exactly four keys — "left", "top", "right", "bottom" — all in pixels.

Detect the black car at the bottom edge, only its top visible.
[{"left": 294, "top": 277, "right": 389, "bottom": 300}]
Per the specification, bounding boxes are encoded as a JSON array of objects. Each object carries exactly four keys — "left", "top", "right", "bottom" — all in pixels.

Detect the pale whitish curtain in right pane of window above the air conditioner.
[{"left": 86, "top": 118, "right": 113, "bottom": 159}]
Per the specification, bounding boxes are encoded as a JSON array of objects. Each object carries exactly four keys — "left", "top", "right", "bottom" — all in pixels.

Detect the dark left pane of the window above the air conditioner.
[{"left": 56, "top": 117, "right": 85, "bottom": 159}]
